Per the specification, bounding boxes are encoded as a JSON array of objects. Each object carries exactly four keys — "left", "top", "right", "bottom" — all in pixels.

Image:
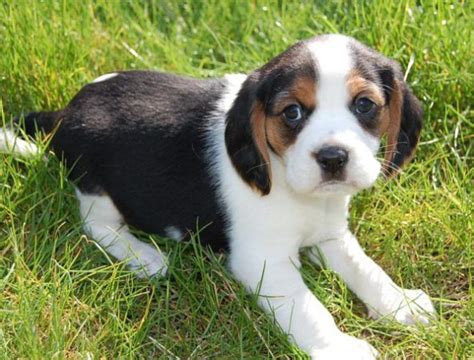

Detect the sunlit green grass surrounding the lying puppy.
[{"left": 0, "top": 0, "right": 474, "bottom": 359}]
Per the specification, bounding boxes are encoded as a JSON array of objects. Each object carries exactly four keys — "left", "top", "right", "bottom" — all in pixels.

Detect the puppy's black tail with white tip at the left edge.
[{"left": 0, "top": 111, "right": 58, "bottom": 157}]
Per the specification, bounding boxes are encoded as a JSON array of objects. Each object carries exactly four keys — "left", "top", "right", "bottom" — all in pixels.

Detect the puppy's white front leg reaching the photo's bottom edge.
[{"left": 230, "top": 241, "right": 377, "bottom": 359}]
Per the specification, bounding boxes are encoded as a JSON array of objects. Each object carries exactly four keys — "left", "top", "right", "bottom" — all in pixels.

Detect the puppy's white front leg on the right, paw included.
[{"left": 315, "top": 232, "right": 435, "bottom": 324}]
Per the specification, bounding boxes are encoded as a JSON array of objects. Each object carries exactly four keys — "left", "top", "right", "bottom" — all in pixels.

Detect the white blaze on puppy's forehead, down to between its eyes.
[{"left": 307, "top": 35, "right": 353, "bottom": 109}]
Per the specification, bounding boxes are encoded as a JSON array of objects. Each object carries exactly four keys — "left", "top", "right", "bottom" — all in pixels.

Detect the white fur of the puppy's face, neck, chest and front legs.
[{"left": 209, "top": 37, "right": 434, "bottom": 359}]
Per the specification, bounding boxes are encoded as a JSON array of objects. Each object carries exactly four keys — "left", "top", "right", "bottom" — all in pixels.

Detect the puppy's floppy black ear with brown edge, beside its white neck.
[{"left": 225, "top": 77, "right": 271, "bottom": 195}]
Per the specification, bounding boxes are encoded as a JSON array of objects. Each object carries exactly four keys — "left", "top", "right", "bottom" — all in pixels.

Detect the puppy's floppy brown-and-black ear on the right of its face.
[{"left": 384, "top": 79, "right": 423, "bottom": 177}]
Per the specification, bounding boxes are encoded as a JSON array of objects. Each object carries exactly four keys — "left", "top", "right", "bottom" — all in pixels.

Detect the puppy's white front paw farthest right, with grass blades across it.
[{"left": 369, "top": 289, "right": 436, "bottom": 325}]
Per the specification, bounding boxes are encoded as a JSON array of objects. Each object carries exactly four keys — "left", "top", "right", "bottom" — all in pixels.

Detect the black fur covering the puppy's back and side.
[{"left": 47, "top": 71, "right": 227, "bottom": 249}]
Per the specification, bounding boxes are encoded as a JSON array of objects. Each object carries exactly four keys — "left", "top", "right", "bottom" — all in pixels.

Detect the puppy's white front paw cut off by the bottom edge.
[{"left": 311, "top": 334, "right": 379, "bottom": 360}]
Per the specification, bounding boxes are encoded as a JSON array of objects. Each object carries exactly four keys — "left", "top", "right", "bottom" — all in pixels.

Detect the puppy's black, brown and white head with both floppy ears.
[{"left": 225, "top": 35, "right": 422, "bottom": 195}]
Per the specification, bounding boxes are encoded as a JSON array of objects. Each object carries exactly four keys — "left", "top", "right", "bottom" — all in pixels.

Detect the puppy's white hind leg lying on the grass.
[{"left": 76, "top": 189, "right": 167, "bottom": 278}]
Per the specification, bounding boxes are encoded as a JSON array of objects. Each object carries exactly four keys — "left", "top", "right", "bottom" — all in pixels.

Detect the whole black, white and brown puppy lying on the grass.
[{"left": 0, "top": 35, "right": 434, "bottom": 359}]
